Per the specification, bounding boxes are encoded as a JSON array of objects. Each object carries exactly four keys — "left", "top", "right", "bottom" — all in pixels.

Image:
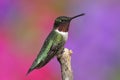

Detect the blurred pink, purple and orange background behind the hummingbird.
[{"left": 0, "top": 0, "right": 120, "bottom": 80}]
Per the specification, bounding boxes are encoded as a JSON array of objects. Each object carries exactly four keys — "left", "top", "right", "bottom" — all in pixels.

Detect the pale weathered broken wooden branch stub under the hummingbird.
[{"left": 57, "top": 48, "right": 73, "bottom": 80}]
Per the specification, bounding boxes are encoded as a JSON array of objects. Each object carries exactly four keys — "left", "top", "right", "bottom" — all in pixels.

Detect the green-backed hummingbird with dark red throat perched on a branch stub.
[{"left": 27, "top": 13, "right": 84, "bottom": 74}]
